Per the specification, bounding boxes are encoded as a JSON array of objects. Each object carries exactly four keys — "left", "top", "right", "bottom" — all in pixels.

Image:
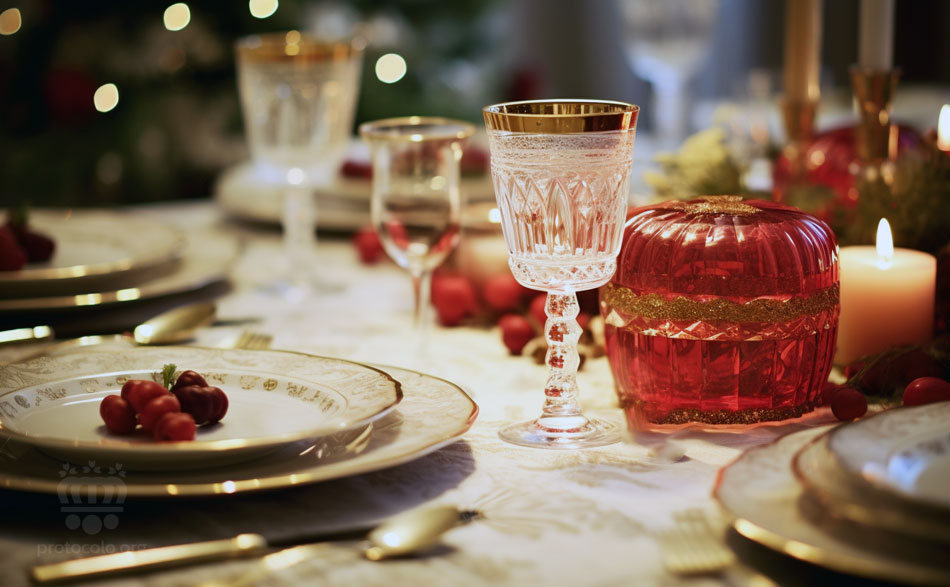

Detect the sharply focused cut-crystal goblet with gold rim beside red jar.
[{"left": 483, "top": 100, "right": 640, "bottom": 448}]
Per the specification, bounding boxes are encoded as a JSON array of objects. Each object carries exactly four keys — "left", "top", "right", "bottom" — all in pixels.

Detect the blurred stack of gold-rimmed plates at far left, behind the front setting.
[{"left": 0, "top": 210, "right": 238, "bottom": 316}]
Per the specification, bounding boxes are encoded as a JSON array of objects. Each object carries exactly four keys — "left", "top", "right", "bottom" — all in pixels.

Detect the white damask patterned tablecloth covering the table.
[{"left": 0, "top": 204, "right": 831, "bottom": 586}]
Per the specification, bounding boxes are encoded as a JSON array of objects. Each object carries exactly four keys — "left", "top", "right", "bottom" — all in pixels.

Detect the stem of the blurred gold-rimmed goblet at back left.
[{"left": 283, "top": 185, "right": 317, "bottom": 287}]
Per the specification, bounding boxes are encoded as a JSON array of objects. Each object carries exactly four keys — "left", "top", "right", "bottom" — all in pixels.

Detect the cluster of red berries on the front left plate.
[{"left": 99, "top": 365, "right": 228, "bottom": 441}]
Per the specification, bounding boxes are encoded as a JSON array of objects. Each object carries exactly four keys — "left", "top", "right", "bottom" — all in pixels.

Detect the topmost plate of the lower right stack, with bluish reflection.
[{"left": 828, "top": 401, "right": 950, "bottom": 513}]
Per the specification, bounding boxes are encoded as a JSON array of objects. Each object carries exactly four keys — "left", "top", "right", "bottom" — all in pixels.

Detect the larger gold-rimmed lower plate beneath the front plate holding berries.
[{"left": 0, "top": 366, "right": 478, "bottom": 500}]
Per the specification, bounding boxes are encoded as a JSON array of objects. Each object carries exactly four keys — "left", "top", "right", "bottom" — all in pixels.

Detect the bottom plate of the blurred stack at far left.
[{"left": 0, "top": 232, "right": 240, "bottom": 312}]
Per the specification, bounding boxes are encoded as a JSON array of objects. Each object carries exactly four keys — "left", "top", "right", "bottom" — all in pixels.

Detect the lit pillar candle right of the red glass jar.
[{"left": 835, "top": 220, "right": 937, "bottom": 365}]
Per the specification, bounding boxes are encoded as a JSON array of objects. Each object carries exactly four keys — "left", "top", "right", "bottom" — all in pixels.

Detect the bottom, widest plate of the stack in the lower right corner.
[{"left": 713, "top": 426, "right": 950, "bottom": 585}]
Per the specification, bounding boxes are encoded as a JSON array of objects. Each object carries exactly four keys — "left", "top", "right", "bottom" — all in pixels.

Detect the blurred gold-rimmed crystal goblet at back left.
[{"left": 235, "top": 31, "right": 364, "bottom": 297}]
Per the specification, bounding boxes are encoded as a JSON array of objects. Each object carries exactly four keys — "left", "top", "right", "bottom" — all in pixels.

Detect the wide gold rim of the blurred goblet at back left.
[{"left": 234, "top": 31, "right": 366, "bottom": 63}]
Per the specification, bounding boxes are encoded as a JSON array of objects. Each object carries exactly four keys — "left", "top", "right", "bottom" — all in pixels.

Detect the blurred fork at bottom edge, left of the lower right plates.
[{"left": 656, "top": 508, "right": 775, "bottom": 587}]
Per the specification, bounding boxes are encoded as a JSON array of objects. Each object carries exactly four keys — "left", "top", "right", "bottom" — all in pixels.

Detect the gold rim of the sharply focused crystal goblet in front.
[{"left": 482, "top": 99, "right": 640, "bottom": 134}]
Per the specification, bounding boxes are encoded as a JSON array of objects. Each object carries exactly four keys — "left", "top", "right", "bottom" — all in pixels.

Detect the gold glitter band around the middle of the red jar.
[{"left": 601, "top": 283, "right": 839, "bottom": 323}]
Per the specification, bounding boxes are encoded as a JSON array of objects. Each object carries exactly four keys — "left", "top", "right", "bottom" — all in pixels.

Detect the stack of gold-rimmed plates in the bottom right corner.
[{"left": 714, "top": 402, "right": 950, "bottom": 585}]
